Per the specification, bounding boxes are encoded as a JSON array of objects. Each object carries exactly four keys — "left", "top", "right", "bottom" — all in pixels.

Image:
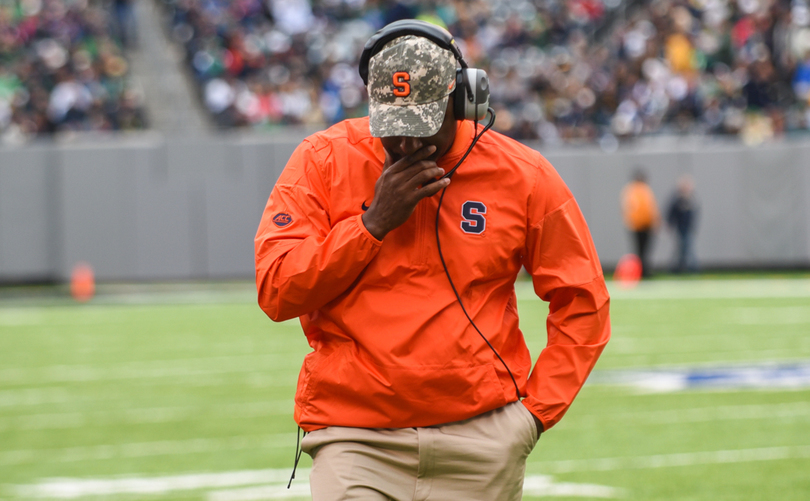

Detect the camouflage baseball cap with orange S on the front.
[{"left": 368, "top": 35, "right": 456, "bottom": 137}]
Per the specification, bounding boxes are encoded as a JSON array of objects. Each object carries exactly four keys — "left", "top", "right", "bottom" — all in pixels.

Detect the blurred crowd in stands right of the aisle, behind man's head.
[{"left": 163, "top": 0, "right": 810, "bottom": 147}]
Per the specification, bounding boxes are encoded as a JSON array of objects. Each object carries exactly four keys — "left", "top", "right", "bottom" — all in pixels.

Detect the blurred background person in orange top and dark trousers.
[{"left": 621, "top": 168, "right": 661, "bottom": 278}]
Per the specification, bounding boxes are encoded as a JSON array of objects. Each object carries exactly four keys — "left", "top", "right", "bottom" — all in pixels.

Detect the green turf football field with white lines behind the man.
[{"left": 0, "top": 278, "right": 810, "bottom": 501}]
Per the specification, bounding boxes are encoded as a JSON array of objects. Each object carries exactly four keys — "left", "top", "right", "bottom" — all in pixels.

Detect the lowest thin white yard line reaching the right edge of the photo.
[{"left": 529, "top": 445, "right": 810, "bottom": 473}]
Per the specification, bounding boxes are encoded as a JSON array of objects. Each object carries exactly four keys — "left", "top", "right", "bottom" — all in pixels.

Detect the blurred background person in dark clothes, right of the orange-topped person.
[{"left": 667, "top": 174, "right": 698, "bottom": 273}]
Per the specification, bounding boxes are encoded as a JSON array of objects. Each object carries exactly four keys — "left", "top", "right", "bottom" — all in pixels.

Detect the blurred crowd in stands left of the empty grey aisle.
[{"left": 0, "top": 0, "right": 146, "bottom": 141}]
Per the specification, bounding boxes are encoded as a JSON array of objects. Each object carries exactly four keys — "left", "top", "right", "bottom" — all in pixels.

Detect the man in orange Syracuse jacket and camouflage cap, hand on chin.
[{"left": 255, "top": 21, "right": 610, "bottom": 501}]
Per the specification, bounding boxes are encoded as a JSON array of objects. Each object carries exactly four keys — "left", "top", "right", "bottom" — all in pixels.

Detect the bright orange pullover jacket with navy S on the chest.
[{"left": 255, "top": 118, "right": 610, "bottom": 431}]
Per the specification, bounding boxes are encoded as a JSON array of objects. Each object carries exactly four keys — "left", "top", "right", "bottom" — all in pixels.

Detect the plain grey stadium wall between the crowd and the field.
[{"left": 0, "top": 131, "right": 810, "bottom": 283}]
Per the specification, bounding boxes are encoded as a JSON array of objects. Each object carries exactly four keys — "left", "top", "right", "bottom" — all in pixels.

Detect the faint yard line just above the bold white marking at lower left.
[{"left": 0, "top": 433, "right": 295, "bottom": 466}]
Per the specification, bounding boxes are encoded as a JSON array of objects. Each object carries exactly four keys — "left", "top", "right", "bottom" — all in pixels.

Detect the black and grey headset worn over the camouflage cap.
[{"left": 359, "top": 19, "right": 489, "bottom": 122}]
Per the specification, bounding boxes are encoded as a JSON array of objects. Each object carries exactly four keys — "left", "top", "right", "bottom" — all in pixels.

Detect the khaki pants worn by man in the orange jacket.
[{"left": 301, "top": 402, "right": 538, "bottom": 501}]
